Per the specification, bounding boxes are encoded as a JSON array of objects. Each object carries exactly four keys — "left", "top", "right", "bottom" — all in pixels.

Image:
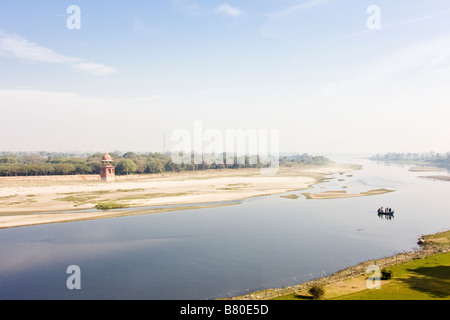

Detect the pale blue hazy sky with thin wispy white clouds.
[{"left": 0, "top": 0, "right": 450, "bottom": 153}]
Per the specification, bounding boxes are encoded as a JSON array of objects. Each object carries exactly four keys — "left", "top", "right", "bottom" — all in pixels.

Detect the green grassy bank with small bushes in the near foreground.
[{"left": 229, "top": 231, "right": 450, "bottom": 300}]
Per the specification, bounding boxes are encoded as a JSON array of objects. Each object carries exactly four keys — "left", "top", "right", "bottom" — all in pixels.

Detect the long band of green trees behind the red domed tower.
[{"left": 0, "top": 152, "right": 330, "bottom": 176}]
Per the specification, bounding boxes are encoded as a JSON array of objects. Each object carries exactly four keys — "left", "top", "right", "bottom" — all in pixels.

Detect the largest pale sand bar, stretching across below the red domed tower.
[{"left": 0, "top": 164, "right": 358, "bottom": 228}]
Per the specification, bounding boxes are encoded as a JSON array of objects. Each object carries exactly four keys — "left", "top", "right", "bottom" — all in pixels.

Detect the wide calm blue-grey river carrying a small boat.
[{"left": 0, "top": 158, "right": 450, "bottom": 300}]
